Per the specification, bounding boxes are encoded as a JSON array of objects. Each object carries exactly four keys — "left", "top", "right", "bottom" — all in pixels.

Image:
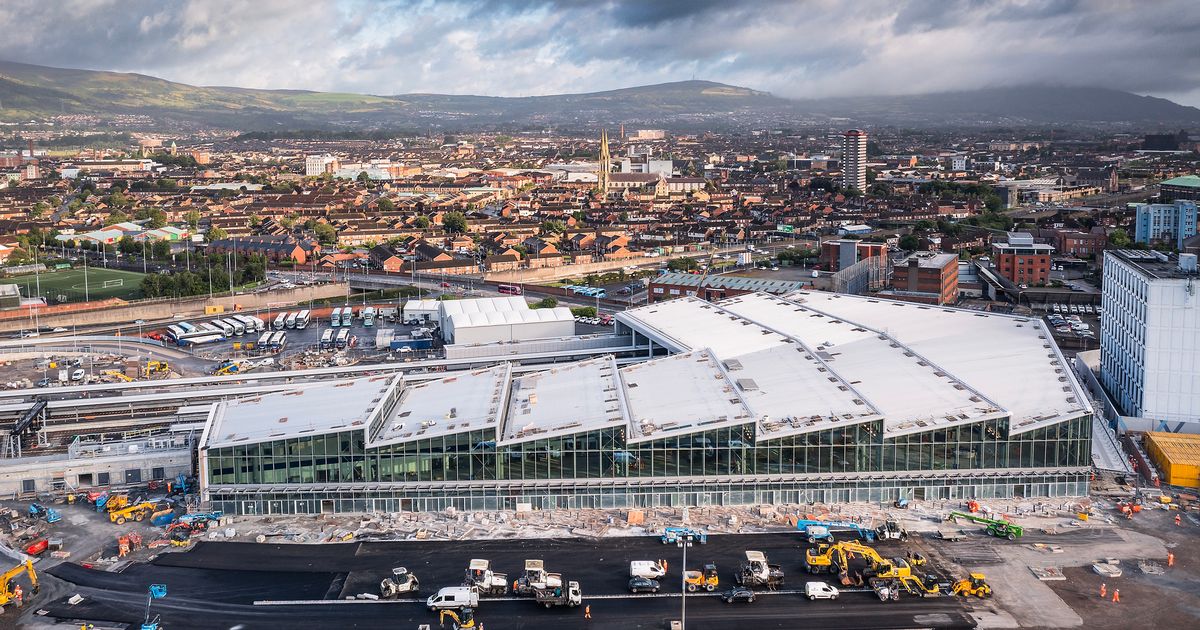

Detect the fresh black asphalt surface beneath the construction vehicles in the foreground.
[{"left": 43, "top": 534, "right": 974, "bottom": 630}]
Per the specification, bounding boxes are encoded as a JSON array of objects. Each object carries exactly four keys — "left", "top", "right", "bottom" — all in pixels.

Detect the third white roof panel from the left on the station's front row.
[{"left": 499, "top": 356, "right": 629, "bottom": 445}]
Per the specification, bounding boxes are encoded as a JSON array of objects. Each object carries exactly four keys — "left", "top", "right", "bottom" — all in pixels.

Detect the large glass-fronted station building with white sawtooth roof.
[{"left": 199, "top": 292, "right": 1092, "bottom": 514}]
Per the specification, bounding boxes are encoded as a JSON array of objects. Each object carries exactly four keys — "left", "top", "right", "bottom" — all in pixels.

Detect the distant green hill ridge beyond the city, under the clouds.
[{"left": 0, "top": 61, "right": 1200, "bottom": 130}]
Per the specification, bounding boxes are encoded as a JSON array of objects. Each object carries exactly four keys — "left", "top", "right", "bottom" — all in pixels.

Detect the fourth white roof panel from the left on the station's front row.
[{"left": 620, "top": 349, "right": 754, "bottom": 444}]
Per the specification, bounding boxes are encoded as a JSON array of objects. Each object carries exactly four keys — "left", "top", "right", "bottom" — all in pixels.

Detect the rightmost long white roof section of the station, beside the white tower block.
[{"left": 790, "top": 292, "right": 1092, "bottom": 434}]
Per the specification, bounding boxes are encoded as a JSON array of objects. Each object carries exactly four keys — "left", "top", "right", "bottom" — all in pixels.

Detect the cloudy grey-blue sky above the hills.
[{"left": 0, "top": 0, "right": 1200, "bottom": 106}]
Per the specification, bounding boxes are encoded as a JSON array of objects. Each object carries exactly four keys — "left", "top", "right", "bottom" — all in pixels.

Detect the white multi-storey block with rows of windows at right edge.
[{"left": 1100, "top": 250, "right": 1200, "bottom": 433}]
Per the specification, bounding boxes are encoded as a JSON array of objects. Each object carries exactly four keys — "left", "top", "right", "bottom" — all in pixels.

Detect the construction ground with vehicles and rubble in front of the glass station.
[{"left": 0, "top": 475, "right": 1200, "bottom": 630}]
